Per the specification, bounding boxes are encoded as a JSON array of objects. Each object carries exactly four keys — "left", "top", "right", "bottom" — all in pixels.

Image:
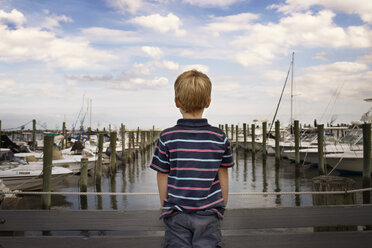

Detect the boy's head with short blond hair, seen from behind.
[{"left": 174, "top": 70, "right": 212, "bottom": 113}]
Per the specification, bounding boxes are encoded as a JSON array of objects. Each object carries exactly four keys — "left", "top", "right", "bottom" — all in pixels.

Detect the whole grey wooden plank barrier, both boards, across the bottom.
[{"left": 0, "top": 205, "right": 372, "bottom": 248}]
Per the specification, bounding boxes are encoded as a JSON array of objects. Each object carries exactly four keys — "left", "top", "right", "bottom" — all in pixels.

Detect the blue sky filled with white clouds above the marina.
[{"left": 0, "top": 0, "right": 372, "bottom": 129}]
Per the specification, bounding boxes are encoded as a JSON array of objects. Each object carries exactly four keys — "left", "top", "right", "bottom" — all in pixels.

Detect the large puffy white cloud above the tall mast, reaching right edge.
[{"left": 231, "top": 10, "right": 372, "bottom": 67}]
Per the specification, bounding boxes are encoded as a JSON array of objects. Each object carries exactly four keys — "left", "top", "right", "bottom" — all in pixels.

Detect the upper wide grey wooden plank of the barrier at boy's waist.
[{"left": 0, "top": 205, "right": 372, "bottom": 231}]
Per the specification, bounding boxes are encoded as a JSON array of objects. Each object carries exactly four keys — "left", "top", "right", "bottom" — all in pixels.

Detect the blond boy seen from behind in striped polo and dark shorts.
[{"left": 151, "top": 70, "right": 234, "bottom": 248}]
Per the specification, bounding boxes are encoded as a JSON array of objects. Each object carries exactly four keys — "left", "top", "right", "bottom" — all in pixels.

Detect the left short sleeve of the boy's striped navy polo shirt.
[{"left": 150, "top": 137, "right": 170, "bottom": 174}]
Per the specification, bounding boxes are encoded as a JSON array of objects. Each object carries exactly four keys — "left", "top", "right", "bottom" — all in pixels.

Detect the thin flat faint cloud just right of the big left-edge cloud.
[{"left": 82, "top": 27, "right": 141, "bottom": 43}]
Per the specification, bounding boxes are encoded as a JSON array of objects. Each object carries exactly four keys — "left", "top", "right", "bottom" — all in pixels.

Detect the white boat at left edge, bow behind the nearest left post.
[{"left": 0, "top": 162, "right": 72, "bottom": 190}]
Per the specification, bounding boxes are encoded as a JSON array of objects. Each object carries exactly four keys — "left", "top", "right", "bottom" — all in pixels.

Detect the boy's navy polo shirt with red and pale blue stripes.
[{"left": 150, "top": 119, "right": 234, "bottom": 217}]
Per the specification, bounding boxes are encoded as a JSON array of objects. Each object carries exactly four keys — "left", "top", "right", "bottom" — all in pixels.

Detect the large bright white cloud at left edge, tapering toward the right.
[{"left": 0, "top": 11, "right": 116, "bottom": 69}]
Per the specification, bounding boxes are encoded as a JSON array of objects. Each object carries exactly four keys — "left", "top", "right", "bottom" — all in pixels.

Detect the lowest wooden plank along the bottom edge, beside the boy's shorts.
[{"left": 0, "top": 232, "right": 372, "bottom": 248}]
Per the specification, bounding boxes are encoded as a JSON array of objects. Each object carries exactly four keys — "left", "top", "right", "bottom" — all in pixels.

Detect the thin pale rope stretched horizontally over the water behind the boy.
[{"left": 1, "top": 188, "right": 372, "bottom": 196}]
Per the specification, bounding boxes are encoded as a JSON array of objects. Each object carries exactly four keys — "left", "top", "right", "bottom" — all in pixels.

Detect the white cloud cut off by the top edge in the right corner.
[{"left": 270, "top": 0, "right": 372, "bottom": 23}]
